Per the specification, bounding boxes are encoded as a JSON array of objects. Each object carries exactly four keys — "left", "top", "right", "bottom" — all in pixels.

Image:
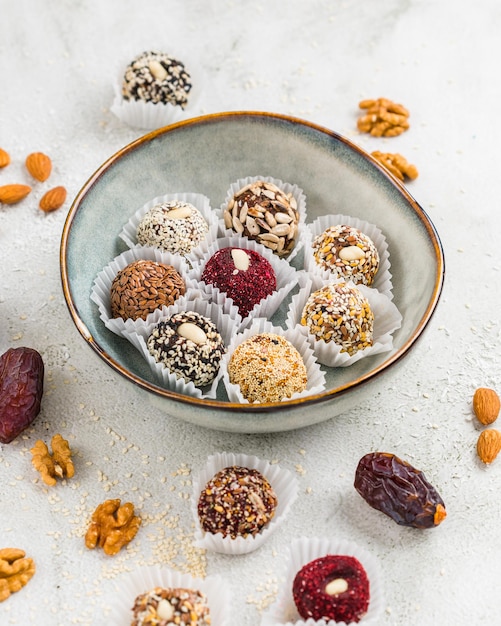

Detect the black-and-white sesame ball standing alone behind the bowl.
[{"left": 122, "top": 51, "right": 192, "bottom": 109}]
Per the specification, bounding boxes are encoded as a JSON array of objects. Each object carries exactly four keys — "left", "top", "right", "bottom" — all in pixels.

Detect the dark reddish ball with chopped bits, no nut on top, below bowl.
[{"left": 198, "top": 465, "right": 277, "bottom": 539}]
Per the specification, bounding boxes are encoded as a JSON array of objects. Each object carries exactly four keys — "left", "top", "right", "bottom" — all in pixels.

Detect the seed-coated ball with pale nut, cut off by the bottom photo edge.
[{"left": 131, "top": 587, "right": 211, "bottom": 626}]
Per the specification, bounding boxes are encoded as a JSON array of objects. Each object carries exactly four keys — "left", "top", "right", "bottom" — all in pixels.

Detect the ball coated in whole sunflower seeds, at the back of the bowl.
[{"left": 223, "top": 181, "right": 299, "bottom": 257}]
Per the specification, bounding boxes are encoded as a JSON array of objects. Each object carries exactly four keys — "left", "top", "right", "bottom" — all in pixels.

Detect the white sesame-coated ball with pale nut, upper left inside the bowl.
[{"left": 137, "top": 201, "right": 209, "bottom": 256}]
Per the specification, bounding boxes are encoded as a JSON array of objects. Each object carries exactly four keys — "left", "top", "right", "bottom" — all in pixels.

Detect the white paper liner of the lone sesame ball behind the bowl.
[{"left": 110, "top": 48, "right": 203, "bottom": 130}]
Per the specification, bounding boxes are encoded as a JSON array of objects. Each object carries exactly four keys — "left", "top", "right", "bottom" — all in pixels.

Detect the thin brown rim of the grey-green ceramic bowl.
[{"left": 59, "top": 110, "right": 445, "bottom": 414}]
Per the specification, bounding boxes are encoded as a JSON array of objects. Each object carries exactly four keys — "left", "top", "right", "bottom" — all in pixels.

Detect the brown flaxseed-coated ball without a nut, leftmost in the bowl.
[{"left": 110, "top": 259, "right": 186, "bottom": 320}]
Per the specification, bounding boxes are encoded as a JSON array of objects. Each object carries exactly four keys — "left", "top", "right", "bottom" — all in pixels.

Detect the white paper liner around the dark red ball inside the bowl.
[{"left": 187, "top": 237, "right": 297, "bottom": 328}]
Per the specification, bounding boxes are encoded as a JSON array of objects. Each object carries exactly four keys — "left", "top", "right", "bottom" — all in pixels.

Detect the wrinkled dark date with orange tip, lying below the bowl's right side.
[{"left": 355, "top": 452, "right": 446, "bottom": 528}]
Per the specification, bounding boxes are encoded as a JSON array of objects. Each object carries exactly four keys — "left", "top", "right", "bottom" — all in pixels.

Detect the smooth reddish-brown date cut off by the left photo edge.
[{"left": 0, "top": 347, "right": 44, "bottom": 443}]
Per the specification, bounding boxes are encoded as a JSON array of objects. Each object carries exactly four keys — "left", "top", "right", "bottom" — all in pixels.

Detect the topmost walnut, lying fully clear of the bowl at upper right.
[{"left": 357, "top": 98, "right": 409, "bottom": 137}]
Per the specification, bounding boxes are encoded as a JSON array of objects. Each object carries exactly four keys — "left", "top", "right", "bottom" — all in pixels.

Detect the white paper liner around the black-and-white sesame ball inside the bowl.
[{"left": 123, "top": 292, "right": 241, "bottom": 398}]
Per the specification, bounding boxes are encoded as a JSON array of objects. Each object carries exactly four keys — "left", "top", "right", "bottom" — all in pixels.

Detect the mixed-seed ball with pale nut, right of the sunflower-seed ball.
[{"left": 312, "top": 224, "right": 379, "bottom": 286}]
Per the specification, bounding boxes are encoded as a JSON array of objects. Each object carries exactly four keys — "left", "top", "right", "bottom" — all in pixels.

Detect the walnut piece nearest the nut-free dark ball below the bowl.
[{"left": 85, "top": 499, "right": 141, "bottom": 556}]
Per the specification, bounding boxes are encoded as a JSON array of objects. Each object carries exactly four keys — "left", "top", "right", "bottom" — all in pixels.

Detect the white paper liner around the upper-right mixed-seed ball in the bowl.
[{"left": 303, "top": 215, "right": 393, "bottom": 300}]
